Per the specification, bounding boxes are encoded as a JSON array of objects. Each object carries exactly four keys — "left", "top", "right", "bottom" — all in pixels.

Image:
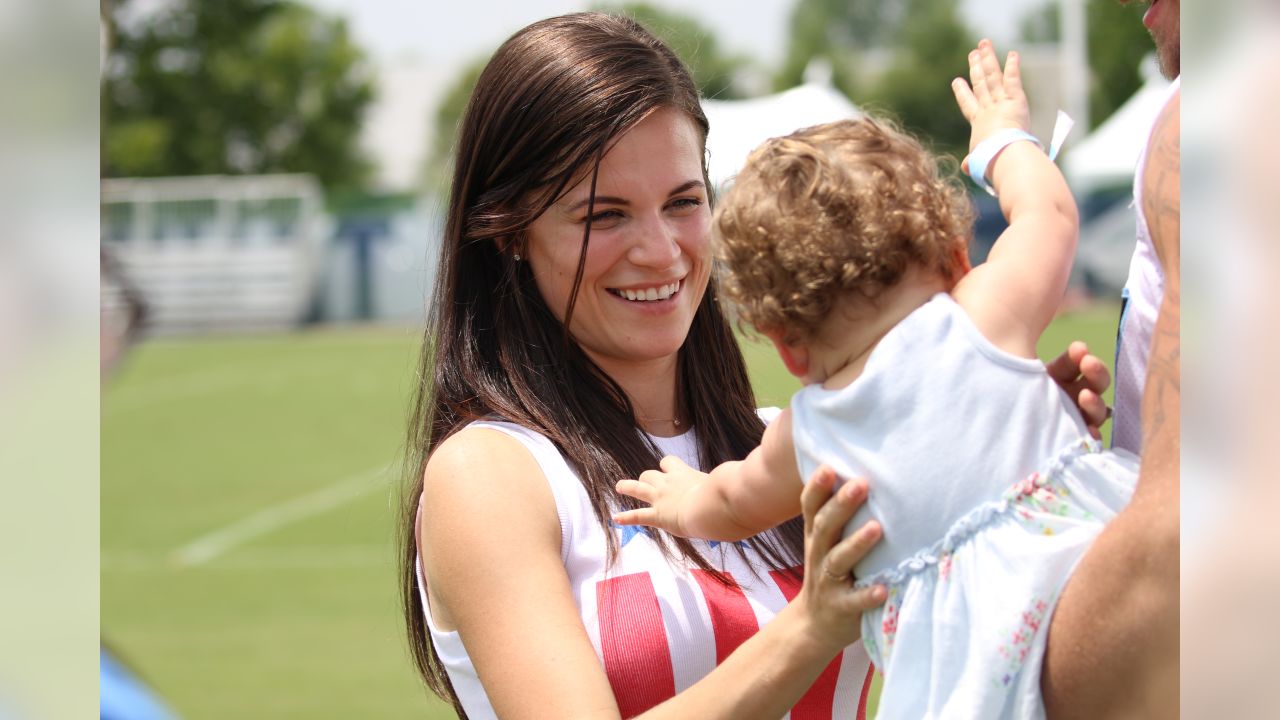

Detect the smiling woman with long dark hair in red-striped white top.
[{"left": 402, "top": 14, "right": 1111, "bottom": 719}]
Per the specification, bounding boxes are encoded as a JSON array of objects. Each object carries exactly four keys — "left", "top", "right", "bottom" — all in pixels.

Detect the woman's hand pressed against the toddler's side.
[{"left": 794, "top": 466, "right": 887, "bottom": 652}]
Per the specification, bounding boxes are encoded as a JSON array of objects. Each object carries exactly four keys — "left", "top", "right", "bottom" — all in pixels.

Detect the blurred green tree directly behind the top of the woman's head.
[{"left": 425, "top": 3, "right": 751, "bottom": 195}]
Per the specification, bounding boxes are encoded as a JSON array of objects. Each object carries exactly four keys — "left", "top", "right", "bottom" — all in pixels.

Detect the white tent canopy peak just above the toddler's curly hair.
[{"left": 703, "top": 82, "right": 860, "bottom": 187}]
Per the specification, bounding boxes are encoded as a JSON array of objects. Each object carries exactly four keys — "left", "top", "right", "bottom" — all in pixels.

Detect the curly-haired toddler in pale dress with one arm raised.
[{"left": 616, "top": 41, "right": 1137, "bottom": 720}]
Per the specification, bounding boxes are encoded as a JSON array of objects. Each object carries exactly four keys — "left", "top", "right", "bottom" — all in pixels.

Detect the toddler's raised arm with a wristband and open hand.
[{"left": 951, "top": 40, "right": 1079, "bottom": 357}]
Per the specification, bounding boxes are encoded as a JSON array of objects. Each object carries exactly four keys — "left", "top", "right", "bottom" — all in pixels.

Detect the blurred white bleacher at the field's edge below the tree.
[{"left": 102, "top": 174, "right": 328, "bottom": 333}]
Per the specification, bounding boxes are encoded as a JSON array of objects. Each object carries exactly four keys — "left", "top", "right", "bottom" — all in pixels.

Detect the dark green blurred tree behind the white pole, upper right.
[{"left": 1021, "top": 0, "right": 1155, "bottom": 128}]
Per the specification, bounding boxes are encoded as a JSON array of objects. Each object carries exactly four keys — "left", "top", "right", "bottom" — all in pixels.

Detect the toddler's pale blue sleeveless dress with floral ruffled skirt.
[{"left": 791, "top": 293, "right": 1138, "bottom": 720}]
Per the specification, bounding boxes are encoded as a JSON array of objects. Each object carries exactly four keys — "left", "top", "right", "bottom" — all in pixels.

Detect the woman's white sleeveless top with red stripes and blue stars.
[{"left": 419, "top": 411, "right": 872, "bottom": 720}]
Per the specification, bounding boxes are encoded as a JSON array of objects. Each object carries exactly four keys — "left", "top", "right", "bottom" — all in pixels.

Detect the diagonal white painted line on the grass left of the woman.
[{"left": 173, "top": 466, "right": 392, "bottom": 568}]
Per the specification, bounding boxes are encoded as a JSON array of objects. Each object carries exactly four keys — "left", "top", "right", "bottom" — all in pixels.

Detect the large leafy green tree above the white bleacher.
[{"left": 102, "top": 0, "right": 374, "bottom": 191}]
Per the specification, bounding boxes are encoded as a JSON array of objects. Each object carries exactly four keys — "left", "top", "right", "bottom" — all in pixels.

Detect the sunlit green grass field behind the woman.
[{"left": 101, "top": 299, "right": 1116, "bottom": 720}]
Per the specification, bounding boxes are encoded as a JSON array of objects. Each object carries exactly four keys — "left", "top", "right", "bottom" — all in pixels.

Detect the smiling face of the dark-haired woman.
[{"left": 526, "top": 109, "right": 710, "bottom": 372}]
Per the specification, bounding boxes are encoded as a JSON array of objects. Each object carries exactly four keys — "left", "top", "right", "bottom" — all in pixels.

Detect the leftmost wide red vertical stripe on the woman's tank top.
[{"left": 595, "top": 573, "right": 676, "bottom": 717}]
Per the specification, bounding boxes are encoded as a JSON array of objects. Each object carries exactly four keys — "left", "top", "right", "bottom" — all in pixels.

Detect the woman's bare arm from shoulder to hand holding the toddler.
[{"left": 421, "top": 429, "right": 883, "bottom": 720}]
